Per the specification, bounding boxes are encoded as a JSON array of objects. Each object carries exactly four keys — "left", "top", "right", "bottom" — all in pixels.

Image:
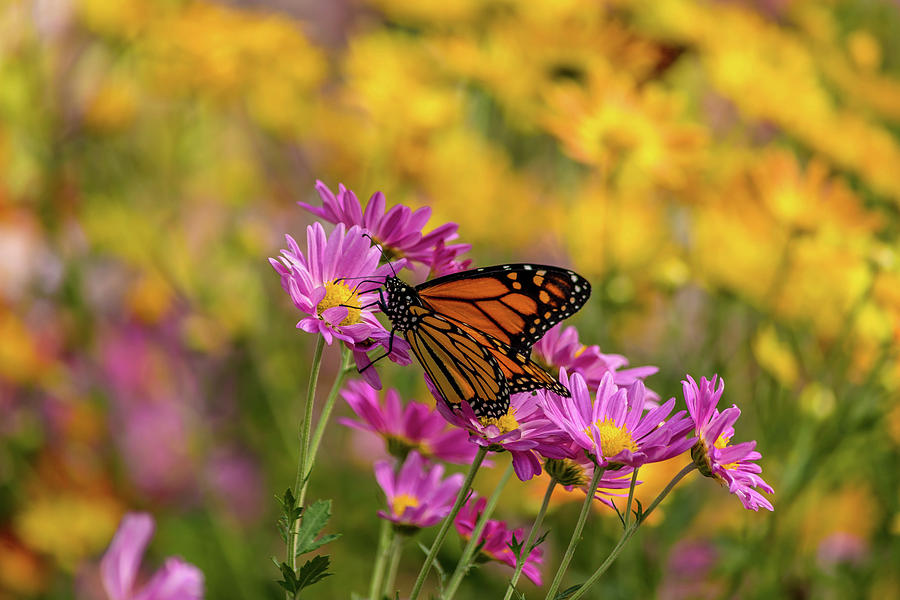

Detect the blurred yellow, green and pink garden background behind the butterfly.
[{"left": 0, "top": 0, "right": 900, "bottom": 600}]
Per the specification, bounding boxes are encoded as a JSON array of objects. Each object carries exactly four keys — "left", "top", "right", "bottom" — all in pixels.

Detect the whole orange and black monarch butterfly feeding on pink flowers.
[{"left": 378, "top": 264, "right": 591, "bottom": 417}]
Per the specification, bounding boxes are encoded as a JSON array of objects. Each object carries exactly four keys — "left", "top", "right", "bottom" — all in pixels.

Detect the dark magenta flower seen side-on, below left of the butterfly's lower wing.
[{"left": 338, "top": 381, "right": 477, "bottom": 464}]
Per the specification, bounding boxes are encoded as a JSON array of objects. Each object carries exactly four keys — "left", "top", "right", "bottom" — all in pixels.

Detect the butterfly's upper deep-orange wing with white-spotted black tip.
[{"left": 416, "top": 264, "right": 591, "bottom": 352}]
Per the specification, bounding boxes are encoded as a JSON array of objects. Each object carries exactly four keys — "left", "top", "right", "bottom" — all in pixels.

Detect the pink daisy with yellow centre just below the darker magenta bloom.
[{"left": 375, "top": 452, "right": 463, "bottom": 528}]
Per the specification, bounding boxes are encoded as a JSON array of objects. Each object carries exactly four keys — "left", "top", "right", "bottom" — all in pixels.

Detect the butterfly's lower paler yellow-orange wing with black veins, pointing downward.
[{"left": 403, "top": 306, "right": 509, "bottom": 417}]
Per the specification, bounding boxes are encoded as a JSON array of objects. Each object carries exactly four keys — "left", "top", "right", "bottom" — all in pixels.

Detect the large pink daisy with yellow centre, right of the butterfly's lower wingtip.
[{"left": 538, "top": 369, "right": 693, "bottom": 467}]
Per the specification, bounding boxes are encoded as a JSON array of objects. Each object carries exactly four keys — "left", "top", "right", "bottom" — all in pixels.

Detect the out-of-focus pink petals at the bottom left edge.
[{"left": 100, "top": 513, "right": 203, "bottom": 600}]
